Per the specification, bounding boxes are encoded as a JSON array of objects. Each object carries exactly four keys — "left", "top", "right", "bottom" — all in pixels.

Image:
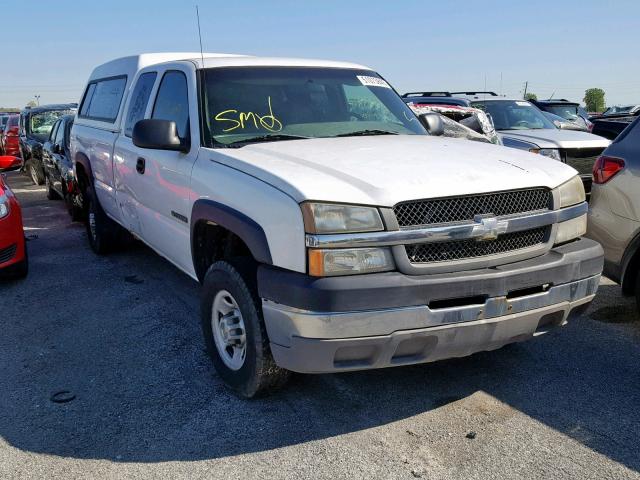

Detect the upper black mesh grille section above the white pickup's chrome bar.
[{"left": 393, "top": 188, "right": 552, "bottom": 227}]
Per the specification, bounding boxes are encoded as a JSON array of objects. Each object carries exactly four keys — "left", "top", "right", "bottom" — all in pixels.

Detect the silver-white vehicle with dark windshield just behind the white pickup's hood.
[{"left": 460, "top": 92, "right": 611, "bottom": 193}]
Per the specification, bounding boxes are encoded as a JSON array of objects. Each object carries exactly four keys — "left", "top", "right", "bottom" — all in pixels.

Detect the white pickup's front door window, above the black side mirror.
[{"left": 151, "top": 71, "right": 189, "bottom": 140}]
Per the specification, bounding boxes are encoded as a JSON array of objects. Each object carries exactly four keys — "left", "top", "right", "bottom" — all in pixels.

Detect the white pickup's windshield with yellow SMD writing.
[{"left": 203, "top": 67, "right": 426, "bottom": 147}]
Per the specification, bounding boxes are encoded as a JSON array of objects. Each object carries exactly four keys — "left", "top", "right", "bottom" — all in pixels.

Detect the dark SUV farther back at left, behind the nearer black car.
[{"left": 20, "top": 103, "right": 78, "bottom": 185}]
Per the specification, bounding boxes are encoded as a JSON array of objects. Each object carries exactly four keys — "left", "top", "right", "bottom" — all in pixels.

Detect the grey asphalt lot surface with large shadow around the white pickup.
[{"left": 0, "top": 173, "right": 640, "bottom": 479}]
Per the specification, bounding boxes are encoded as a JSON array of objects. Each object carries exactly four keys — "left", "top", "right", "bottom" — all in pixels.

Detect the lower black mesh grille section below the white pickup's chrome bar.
[{"left": 405, "top": 227, "right": 551, "bottom": 263}]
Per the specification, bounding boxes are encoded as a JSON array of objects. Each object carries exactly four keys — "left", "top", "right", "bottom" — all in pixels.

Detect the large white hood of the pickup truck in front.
[{"left": 203, "top": 135, "right": 576, "bottom": 207}]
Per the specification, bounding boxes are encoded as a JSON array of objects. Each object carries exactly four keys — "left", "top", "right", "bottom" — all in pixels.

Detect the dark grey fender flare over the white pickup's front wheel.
[{"left": 191, "top": 199, "right": 273, "bottom": 274}]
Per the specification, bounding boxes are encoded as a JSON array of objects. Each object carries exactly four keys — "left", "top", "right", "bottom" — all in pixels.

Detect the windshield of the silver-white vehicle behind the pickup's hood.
[{"left": 471, "top": 100, "right": 556, "bottom": 130}]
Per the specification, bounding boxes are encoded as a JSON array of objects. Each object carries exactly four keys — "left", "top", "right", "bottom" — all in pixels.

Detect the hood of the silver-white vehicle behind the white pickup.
[{"left": 498, "top": 128, "right": 611, "bottom": 148}]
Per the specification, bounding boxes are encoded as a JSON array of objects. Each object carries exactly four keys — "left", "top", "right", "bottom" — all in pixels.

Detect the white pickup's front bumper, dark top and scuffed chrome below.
[{"left": 258, "top": 239, "right": 603, "bottom": 373}]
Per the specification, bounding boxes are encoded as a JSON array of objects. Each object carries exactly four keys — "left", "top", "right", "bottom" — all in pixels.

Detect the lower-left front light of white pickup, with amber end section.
[{"left": 309, "top": 248, "right": 395, "bottom": 277}]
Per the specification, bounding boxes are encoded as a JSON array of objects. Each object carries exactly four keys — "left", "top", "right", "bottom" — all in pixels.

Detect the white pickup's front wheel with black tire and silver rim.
[{"left": 201, "top": 259, "right": 289, "bottom": 398}]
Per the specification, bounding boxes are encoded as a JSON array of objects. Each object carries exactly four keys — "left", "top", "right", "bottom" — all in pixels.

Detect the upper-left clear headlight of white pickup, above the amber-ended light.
[{"left": 302, "top": 202, "right": 384, "bottom": 233}]
